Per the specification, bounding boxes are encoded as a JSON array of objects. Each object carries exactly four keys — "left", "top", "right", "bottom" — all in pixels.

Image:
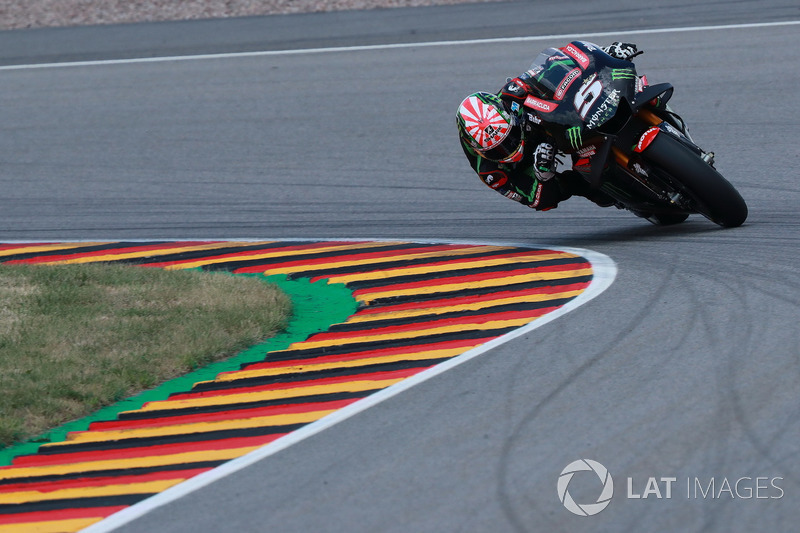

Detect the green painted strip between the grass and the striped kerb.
[{"left": 0, "top": 274, "right": 358, "bottom": 466}]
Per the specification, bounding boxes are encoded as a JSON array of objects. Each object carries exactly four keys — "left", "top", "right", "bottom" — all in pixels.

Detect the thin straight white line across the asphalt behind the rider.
[{"left": 0, "top": 20, "right": 800, "bottom": 70}]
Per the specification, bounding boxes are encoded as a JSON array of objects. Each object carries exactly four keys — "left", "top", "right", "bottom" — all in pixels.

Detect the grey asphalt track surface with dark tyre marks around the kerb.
[{"left": 0, "top": 1, "right": 800, "bottom": 532}]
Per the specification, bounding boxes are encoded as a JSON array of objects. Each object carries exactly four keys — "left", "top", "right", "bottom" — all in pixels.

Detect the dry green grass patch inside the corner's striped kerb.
[{"left": 0, "top": 264, "right": 291, "bottom": 447}]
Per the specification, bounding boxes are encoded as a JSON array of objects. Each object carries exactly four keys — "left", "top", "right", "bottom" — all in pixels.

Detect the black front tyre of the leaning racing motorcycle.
[{"left": 642, "top": 132, "right": 747, "bottom": 228}]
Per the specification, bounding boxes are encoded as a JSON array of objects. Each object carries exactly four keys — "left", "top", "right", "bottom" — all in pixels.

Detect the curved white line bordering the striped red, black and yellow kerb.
[{"left": 82, "top": 239, "right": 617, "bottom": 533}]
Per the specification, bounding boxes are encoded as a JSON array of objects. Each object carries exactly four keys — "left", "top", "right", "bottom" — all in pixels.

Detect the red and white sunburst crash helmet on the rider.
[{"left": 456, "top": 92, "right": 525, "bottom": 163}]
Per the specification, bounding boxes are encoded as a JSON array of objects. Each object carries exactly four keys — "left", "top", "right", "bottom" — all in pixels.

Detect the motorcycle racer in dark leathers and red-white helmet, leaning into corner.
[{"left": 456, "top": 42, "right": 642, "bottom": 211}]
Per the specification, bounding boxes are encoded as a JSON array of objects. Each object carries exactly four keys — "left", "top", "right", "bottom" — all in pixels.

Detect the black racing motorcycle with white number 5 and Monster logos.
[{"left": 524, "top": 41, "right": 747, "bottom": 227}]
